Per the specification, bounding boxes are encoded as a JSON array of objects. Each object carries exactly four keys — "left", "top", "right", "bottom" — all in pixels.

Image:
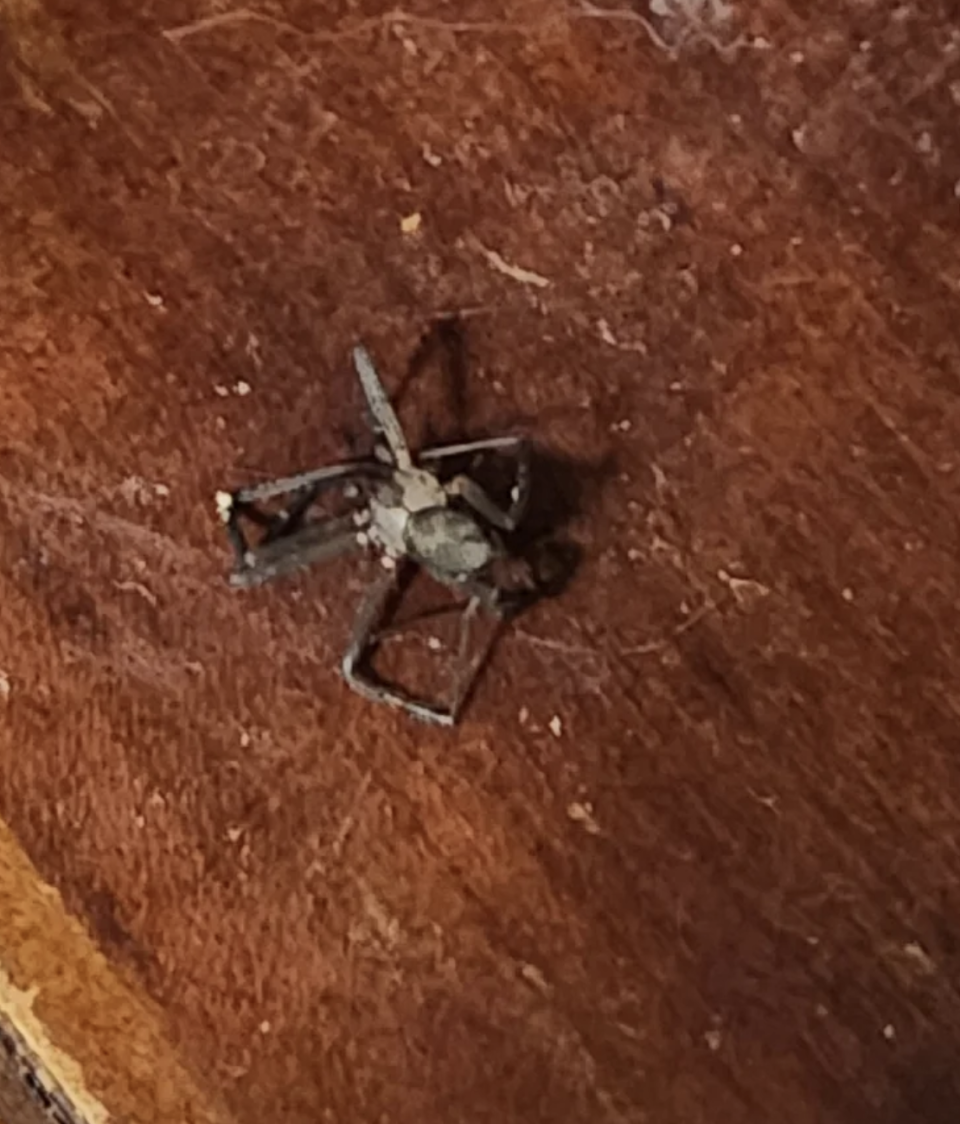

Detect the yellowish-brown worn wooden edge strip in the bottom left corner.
[{"left": 0, "top": 821, "right": 234, "bottom": 1124}]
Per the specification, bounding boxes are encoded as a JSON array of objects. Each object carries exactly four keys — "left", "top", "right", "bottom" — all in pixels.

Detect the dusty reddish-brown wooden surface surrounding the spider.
[{"left": 0, "top": 0, "right": 960, "bottom": 1124}]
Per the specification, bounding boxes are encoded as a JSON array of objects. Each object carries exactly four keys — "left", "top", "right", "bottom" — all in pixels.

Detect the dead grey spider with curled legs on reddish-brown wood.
[{"left": 217, "top": 345, "right": 534, "bottom": 726}]
